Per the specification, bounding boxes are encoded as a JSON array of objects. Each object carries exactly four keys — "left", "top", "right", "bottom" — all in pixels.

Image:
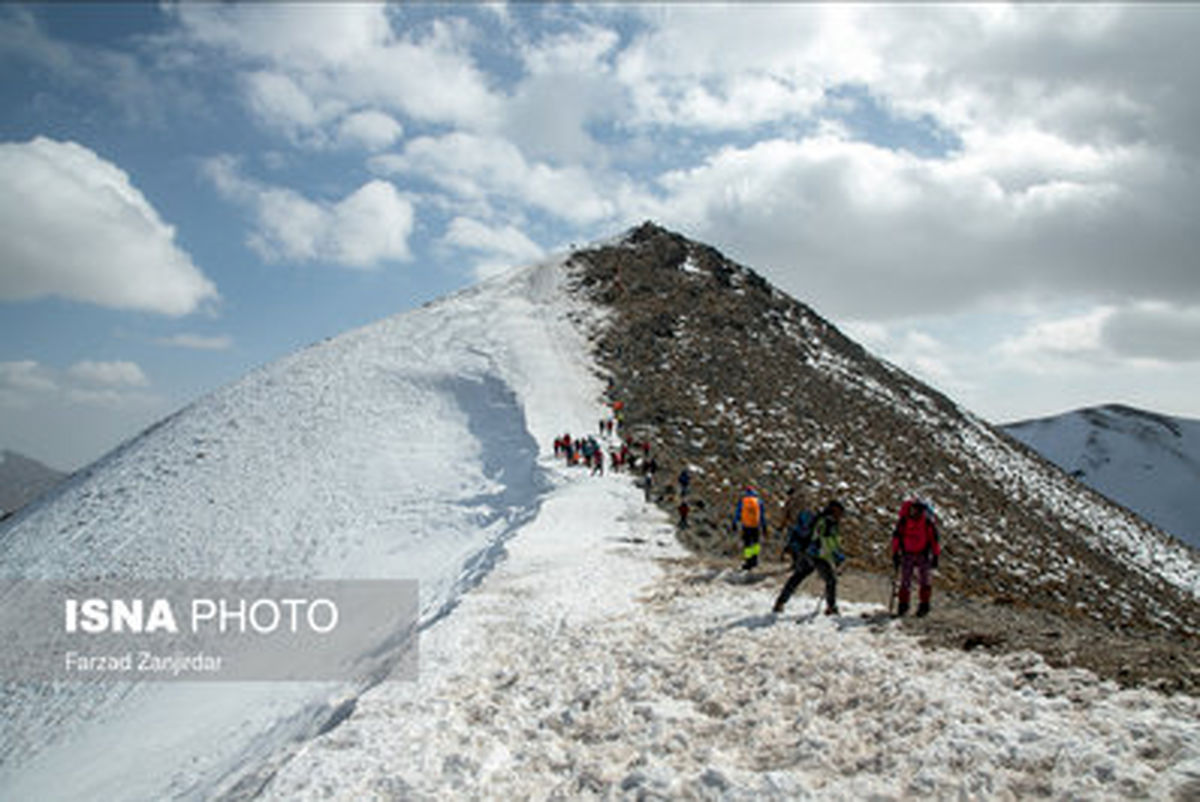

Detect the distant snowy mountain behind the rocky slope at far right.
[{"left": 1004, "top": 406, "right": 1200, "bottom": 549}]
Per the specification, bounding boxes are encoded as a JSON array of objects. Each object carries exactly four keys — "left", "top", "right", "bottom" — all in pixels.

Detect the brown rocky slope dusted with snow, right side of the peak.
[{"left": 569, "top": 223, "right": 1200, "bottom": 681}]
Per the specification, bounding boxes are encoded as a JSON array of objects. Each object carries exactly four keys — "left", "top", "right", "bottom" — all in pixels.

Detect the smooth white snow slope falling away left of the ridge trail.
[{"left": 0, "top": 258, "right": 600, "bottom": 800}]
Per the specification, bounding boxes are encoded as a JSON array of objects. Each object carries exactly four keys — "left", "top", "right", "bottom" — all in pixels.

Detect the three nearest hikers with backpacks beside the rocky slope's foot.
[{"left": 733, "top": 487, "right": 942, "bottom": 617}]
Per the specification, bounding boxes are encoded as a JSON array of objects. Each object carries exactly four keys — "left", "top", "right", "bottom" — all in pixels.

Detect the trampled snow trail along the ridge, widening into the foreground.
[{"left": 265, "top": 472, "right": 1200, "bottom": 800}]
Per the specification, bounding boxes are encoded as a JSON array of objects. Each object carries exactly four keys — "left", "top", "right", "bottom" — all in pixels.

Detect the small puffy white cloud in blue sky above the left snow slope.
[{"left": 204, "top": 157, "right": 413, "bottom": 268}]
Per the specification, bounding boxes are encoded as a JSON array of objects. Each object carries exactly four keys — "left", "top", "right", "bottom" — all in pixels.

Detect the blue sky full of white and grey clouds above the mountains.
[{"left": 0, "top": 2, "right": 1200, "bottom": 469}]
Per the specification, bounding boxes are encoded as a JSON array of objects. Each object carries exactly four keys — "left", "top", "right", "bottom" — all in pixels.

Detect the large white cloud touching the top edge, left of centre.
[{"left": 173, "top": 4, "right": 500, "bottom": 133}]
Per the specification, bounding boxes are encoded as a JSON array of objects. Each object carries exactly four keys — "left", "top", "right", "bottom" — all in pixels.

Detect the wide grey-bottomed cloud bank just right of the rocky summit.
[{"left": 655, "top": 126, "right": 1200, "bottom": 318}]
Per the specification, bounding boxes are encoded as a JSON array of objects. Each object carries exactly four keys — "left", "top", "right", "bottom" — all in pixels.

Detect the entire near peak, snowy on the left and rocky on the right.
[{"left": 0, "top": 220, "right": 1200, "bottom": 800}]
